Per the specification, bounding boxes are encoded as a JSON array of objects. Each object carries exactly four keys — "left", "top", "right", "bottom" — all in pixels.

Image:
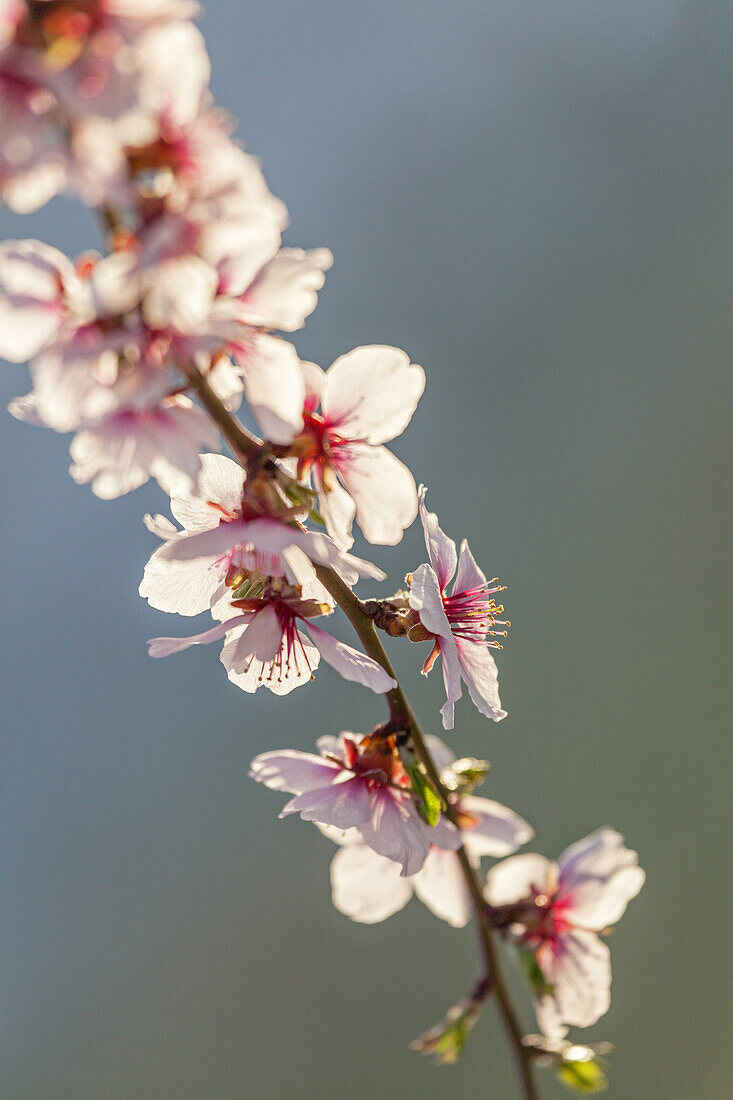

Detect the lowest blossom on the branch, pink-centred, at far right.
[{"left": 486, "top": 828, "right": 644, "bottom": 1037}]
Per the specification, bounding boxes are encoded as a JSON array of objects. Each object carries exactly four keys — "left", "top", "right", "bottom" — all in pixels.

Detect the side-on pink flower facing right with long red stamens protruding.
[{"left": 408, "top": 486, "right": 508, "bottom": 729}]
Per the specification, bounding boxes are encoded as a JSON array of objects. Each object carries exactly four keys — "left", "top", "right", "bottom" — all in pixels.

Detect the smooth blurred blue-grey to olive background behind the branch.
[{"left": 0, "top": 0, "right": 733, "bottom": 1100}]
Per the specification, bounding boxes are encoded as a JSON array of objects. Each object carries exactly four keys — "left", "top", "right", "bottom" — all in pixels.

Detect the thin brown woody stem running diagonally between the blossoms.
[{"left": 182, "top": 365, "right": 538, "bottom": 1100}]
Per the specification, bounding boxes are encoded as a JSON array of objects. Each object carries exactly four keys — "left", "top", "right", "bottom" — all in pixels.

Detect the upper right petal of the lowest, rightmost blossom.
[{"left": 558, "top": 828, "right": 645, "bottom": 932}]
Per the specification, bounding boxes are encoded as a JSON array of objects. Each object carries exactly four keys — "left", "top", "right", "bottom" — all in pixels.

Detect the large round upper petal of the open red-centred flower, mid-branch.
[{"left": 321, "top": 344, "right": 425, "bottom": 443}]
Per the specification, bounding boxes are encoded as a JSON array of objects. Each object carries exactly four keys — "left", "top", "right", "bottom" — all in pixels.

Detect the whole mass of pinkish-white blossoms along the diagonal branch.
[{"left": 0, "top": 0, "right": 644, "bottom": 1091}]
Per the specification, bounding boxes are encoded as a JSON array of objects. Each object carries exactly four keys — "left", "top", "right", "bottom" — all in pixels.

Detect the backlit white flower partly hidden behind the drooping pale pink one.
[{"left": 321, "top": 737, "right": 534, "bottom": 928}]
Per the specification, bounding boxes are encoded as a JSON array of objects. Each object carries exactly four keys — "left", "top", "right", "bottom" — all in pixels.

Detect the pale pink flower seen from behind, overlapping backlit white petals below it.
[{"left": 250, "top": 734, "right": 460, "bottom": 876}]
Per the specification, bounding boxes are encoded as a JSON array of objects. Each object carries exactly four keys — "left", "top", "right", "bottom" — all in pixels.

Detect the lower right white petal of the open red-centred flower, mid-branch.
[{"left": 335, "top": 444, "right": 417, "bottom": 546}]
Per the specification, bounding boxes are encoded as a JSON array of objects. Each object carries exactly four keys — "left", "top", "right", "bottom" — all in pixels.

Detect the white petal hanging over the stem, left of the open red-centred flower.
[{"left": 242, "top": 336, "right": 305, "bottom": 443}]
